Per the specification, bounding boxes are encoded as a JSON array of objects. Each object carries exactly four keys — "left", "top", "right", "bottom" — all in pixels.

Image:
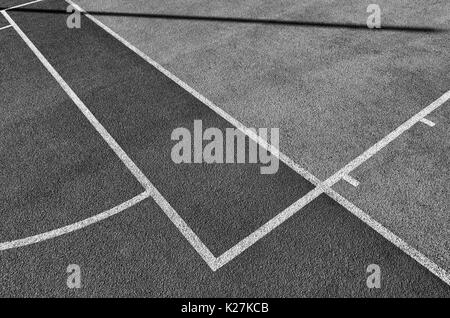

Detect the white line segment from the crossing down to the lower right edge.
[{"left": 326, "top": 188, "right": 450, "bottom": 286}]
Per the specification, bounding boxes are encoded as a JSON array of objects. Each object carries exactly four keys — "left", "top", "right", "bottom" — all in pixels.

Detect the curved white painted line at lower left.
[{"left": 0, "top": 191, "right": 150, "bottom": 251}]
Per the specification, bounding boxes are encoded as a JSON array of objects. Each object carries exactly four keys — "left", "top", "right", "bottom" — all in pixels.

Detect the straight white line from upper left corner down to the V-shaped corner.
[{"left": 1, "top": 11, "right": 216, "bottom": 269}]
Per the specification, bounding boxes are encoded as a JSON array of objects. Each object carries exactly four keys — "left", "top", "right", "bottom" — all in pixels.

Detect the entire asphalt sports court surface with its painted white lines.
[{"left": 0, "top": 0, "right": 450, "bottom": 297}]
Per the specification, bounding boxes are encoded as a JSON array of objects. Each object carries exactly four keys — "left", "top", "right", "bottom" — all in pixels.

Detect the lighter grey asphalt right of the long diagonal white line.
[{"left": 74, "top": 0, "right": 450, "bottom": 284}]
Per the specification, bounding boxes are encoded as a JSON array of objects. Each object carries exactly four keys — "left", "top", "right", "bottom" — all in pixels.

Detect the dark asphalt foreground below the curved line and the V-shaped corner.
[{"left": 0, "top": 196, "right": 450, "bottom": 297}]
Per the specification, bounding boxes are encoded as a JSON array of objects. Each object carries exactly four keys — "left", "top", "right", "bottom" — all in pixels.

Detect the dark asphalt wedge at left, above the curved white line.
[{"left": 0, "top": 28, "right": 144, "bottom": 242}]
